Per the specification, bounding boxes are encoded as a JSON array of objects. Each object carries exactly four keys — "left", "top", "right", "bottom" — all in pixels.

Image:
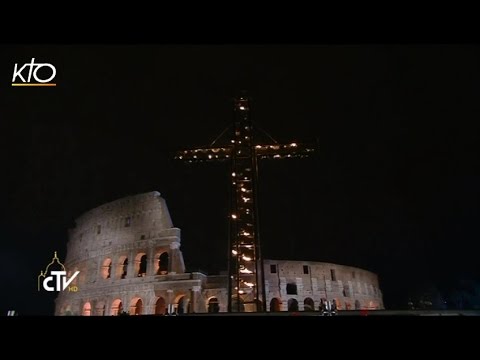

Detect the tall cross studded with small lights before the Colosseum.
[{"left": 175, "top": 96, "right": 315, "bottom": 312}]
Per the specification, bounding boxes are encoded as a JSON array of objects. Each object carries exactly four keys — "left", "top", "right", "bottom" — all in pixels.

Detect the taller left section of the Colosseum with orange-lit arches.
[{"left": 55, "top": 192, "right": 199, "bottom": 315}]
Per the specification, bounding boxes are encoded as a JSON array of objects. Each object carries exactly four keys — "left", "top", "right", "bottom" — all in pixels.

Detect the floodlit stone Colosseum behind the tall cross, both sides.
[{"left": 55, "top": 192, "right": 383, "bottom": 316}]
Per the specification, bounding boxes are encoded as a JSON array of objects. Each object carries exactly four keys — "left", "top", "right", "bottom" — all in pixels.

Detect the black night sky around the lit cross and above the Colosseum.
[{"left": 0, "top": 45, "right": 480, "bottom": 315}]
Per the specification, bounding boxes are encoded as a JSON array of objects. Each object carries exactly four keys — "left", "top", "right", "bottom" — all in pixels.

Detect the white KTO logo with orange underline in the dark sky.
[{"left": 12, "top": 58, "right": 57, "bottom": 86}]
